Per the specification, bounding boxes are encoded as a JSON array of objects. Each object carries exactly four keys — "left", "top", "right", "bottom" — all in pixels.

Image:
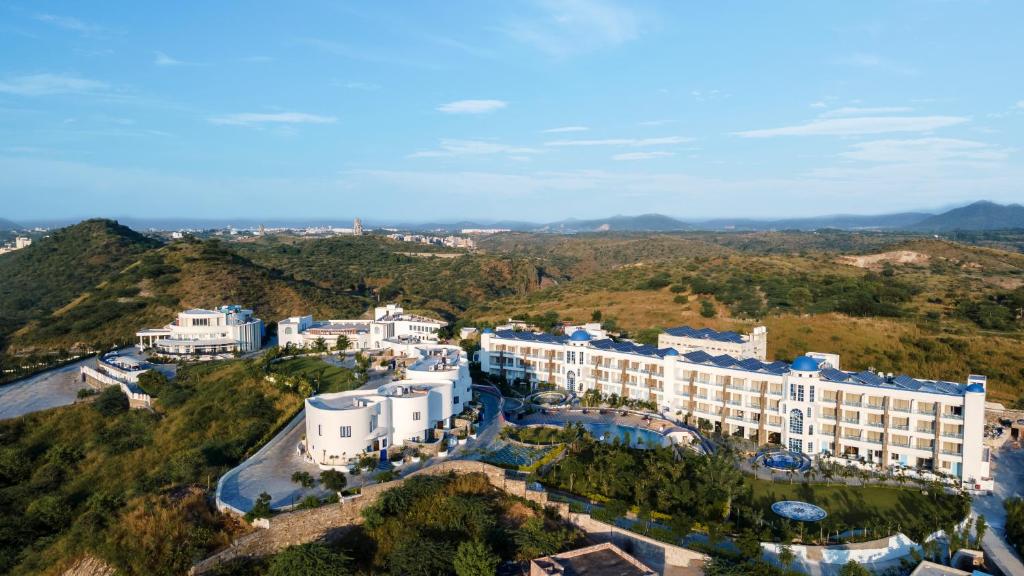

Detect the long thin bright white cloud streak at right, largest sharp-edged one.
[{"left": 734, "top": 116, "right": 968, "bottom": 138}]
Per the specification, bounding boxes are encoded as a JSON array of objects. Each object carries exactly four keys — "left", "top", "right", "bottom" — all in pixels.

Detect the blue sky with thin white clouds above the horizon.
[{"left": 0, "top": 0, "right": 1024, "bottom": 221}]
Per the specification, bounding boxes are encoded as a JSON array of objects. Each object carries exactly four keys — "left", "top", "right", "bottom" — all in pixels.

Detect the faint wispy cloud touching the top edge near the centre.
[{"left": 505, "top": 0, "right": 640, "bottom": 57}]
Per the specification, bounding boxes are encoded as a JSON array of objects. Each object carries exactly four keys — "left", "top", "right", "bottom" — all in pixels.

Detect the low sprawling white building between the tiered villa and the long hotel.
[{"left": 278, "top": 304, "right": 447, "bottom": 349}]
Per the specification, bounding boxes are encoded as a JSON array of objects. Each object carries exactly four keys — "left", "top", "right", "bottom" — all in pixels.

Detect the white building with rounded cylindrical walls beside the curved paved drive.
[{"left": 304, "top": 344, "right": 472, "bottom": 468}]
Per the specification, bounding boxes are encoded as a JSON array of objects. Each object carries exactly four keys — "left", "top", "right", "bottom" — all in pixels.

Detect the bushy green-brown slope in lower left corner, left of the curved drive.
[{"left": 0, "top": 361, "right": 302, "bottom": 575}]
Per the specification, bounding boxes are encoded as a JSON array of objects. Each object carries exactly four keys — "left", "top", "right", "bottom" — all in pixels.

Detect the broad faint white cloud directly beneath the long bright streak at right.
[{"left": 840, "top": 138, "right": 1009, "bottom": 163}]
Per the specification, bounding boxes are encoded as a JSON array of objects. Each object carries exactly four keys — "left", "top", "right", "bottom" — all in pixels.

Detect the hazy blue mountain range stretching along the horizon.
[{"left": 14, "top": 201, "right": 1024, "bottom": 234}]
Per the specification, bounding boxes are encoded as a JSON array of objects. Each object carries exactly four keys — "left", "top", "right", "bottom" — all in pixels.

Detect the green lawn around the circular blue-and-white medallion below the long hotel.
[{"left": 749, "top": 479, "right": 970, "bottom": 541}]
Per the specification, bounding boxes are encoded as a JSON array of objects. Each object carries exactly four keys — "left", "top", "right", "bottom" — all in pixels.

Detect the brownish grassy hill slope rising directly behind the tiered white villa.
[{"left": 11, "top": 243, "right": 367, "bottom": 352}]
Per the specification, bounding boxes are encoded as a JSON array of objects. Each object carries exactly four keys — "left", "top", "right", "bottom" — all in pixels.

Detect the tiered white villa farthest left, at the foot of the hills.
[{"left": 135, "top": 305, "right": 263, "bottom": 357}]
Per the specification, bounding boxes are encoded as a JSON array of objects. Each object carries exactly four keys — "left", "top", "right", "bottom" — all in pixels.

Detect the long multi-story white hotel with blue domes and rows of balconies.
[{"left": 479, "top": 329, "right": 989, "bottom": 485}]
